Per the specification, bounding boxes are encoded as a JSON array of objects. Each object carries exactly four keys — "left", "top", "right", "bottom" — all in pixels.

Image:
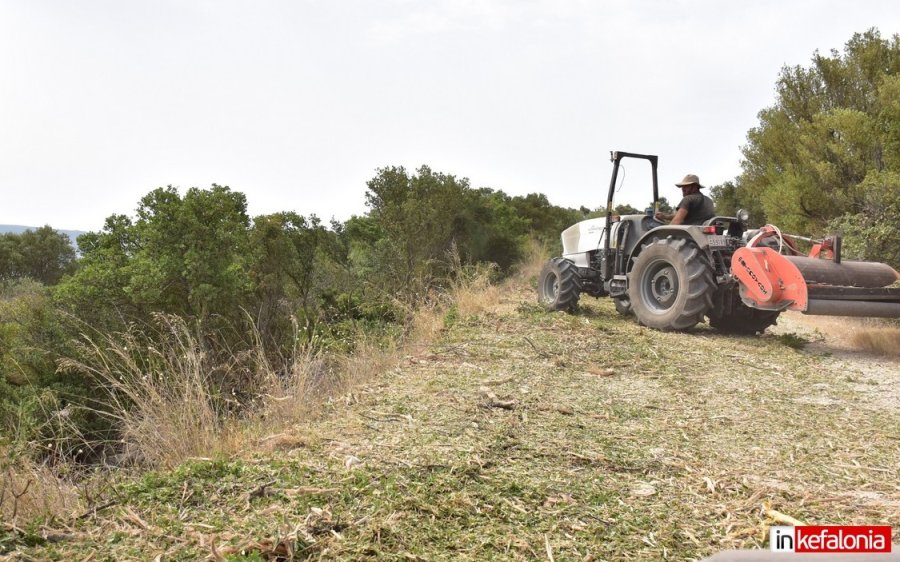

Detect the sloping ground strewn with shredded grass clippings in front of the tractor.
[{"left": 7, "top": 286, "right": 900, "bottom": 561}]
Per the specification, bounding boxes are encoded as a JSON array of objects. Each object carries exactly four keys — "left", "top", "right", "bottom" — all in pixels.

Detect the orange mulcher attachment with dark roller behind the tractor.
[{"left": 731, "top": 225, "right": 900, "bottom": 318}]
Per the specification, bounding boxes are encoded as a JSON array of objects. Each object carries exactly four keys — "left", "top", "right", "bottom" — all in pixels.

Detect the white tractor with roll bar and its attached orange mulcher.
[{"left": 538, "top": 151, "right": 900, "bottom": 334}]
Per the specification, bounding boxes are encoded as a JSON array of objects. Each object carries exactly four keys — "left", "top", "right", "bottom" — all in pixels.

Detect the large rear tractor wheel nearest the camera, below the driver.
[{"left": 628, "top": 236, "right": 715, "bottom": 330}]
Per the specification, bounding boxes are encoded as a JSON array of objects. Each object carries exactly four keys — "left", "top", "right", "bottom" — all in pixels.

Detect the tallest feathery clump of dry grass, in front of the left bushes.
[{"left": 61, "top": 315, "right": 233, "bottom": 467}]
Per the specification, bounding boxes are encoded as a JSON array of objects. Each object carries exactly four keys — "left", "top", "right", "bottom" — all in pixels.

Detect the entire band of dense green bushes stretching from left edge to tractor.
[{"left": 0, "top": 171, "right": 584, "bottom": 460}]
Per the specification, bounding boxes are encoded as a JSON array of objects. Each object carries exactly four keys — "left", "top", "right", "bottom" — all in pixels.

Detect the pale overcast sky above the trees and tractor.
[{"left": 0, "top": 0, "right": 900, "bottom": 230}]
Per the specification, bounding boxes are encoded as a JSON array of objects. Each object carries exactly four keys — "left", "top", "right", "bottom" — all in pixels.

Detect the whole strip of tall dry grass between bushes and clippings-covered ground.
[{"left": 0, "top": 243, "right": 524, "bottom": 523}]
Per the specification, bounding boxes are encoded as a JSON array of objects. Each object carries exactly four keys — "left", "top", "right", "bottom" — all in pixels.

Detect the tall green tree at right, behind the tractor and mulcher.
[{"left": 740, "top": 29, "right": 900, "bottom": 238}]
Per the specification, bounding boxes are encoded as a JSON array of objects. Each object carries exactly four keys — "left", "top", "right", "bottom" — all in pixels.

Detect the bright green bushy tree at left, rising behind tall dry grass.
[{"left": 57, "top": 185, "right": 252, "bottom": 325}]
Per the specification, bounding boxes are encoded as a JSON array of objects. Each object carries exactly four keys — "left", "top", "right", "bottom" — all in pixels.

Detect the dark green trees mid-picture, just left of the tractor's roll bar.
[{"left": 362, "top": 166, "right": 587, "bottom": 296}]
